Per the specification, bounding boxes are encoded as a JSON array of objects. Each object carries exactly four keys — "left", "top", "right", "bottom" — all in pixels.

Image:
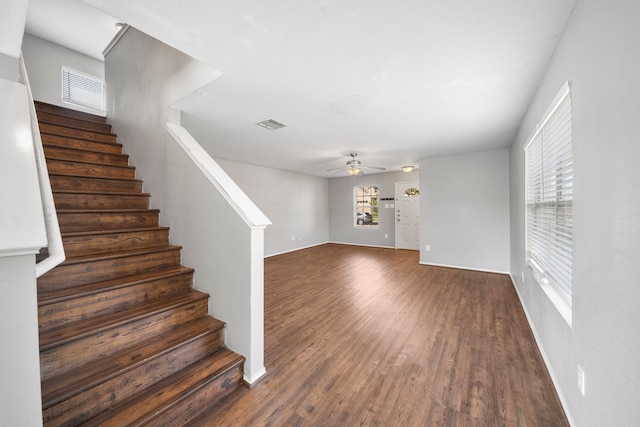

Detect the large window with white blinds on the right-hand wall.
[{"left": 525, "top": 82, "right": 573, "bottom": 323}]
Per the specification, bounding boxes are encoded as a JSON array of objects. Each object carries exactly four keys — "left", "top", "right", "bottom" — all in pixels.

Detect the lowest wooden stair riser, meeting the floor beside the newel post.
[{"left": 146, "top": 365, "right": 244, "bottom": 427}]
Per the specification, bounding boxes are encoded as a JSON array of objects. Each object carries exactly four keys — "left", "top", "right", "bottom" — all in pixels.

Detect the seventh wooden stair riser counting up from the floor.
[{"left": 58, "top": 211, "right": 158, "bottom": 233}]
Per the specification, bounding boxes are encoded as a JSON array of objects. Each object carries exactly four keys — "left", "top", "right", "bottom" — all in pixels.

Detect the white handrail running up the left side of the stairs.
[{"left": 20, "top": 56, "right": 65, "bottom": 277}]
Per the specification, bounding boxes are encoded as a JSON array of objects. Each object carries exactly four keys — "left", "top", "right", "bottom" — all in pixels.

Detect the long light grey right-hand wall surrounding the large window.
[{"left": 511, "top": 0, "right": 640, "bottom": 426}]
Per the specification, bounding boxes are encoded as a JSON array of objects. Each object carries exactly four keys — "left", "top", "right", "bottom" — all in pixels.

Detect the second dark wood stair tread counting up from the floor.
[{"left": 42, "top": 316, "right": 225, "bottom": 409}]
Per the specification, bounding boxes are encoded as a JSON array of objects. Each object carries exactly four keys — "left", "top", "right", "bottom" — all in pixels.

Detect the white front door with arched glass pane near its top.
[{"left": 395, "top": 181, "right": 420, "bottom": 250}]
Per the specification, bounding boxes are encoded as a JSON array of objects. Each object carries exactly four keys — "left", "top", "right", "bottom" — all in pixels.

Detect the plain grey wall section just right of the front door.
[{"left": 420, "top": 148, "right": 509, "bottom": 273}]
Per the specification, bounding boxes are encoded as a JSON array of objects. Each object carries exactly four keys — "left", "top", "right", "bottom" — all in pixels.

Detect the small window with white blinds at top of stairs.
[{"left": 62, "top": 67, "right": 104, "bottom": 111}]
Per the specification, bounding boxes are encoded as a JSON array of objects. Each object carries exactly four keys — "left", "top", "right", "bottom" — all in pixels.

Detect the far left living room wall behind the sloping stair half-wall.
[{"left": 216, "top": 159, "right": 329, "bottom": 256}]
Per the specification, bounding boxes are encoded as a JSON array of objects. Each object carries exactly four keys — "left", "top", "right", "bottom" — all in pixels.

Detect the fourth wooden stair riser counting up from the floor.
[{"left": 38, "top": 273, "right": 193, "bottom": 333}]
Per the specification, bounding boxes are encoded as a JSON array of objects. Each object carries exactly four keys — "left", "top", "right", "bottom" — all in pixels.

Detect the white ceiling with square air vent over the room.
[{"left": 27, "top": 0, "right": 576, "bottom": 176}]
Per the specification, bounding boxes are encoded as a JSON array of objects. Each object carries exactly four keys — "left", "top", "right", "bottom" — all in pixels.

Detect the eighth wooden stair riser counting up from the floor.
[{"left": 53, "top": 193, "right": 149, "bottom": 210}]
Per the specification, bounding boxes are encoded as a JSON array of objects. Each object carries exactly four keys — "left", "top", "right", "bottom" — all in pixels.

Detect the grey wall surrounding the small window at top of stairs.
[{"left": 22, "top": 33, "right": 104, "bottom": 114}]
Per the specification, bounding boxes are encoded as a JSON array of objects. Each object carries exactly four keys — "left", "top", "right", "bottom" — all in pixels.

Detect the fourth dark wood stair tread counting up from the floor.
[{"left": 38, "top": 266, "right": 194, "bottom": 306}]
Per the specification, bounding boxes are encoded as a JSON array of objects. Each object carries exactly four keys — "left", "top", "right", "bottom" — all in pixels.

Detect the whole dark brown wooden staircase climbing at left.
[{"left": 35, "top": 102, "right": 244, "bottom": 427}]
